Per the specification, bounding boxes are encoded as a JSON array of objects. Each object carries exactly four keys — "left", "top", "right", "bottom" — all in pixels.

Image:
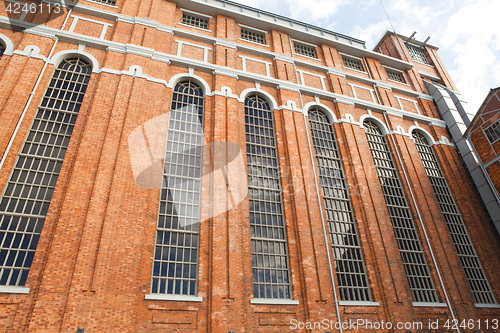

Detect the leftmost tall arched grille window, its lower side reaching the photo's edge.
[{"left": 0, "top": 59, "right": 92, "bottom": 287}]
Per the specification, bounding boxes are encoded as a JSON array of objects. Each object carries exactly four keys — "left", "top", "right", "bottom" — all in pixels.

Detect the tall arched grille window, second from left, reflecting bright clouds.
[{"left": 151, "top": 80, "right": 204, "bottom": 296}]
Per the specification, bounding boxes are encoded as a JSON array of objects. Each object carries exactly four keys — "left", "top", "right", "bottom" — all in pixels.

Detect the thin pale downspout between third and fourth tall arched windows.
[{"left": 288, "top": 35, "right": 343, "bottom": 333}]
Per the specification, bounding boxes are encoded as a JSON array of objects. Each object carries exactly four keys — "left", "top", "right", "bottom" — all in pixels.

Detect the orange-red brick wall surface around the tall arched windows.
[{"left": 0, "top": 1, "right": 500, "bottom": 332}]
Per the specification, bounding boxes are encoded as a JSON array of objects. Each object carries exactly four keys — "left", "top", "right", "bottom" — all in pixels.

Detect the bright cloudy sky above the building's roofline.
[{"left": 236, "top": 0, "right": 500, "bottom": 113}]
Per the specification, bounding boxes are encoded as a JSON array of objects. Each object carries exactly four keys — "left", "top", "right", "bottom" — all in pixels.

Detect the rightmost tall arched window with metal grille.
[{"left": 413, "top": 131, "right": 496, "bottom": 304}]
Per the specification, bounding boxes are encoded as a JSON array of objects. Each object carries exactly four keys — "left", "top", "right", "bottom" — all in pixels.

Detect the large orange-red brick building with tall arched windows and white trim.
[{"left": 0, "top": 0, "right": 500, "bottom": 333}]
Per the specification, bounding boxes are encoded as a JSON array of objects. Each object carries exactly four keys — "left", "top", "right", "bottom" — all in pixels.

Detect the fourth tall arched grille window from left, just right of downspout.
[{"left": 309, "top": 108, "right": 372, "bottom": 301}]
